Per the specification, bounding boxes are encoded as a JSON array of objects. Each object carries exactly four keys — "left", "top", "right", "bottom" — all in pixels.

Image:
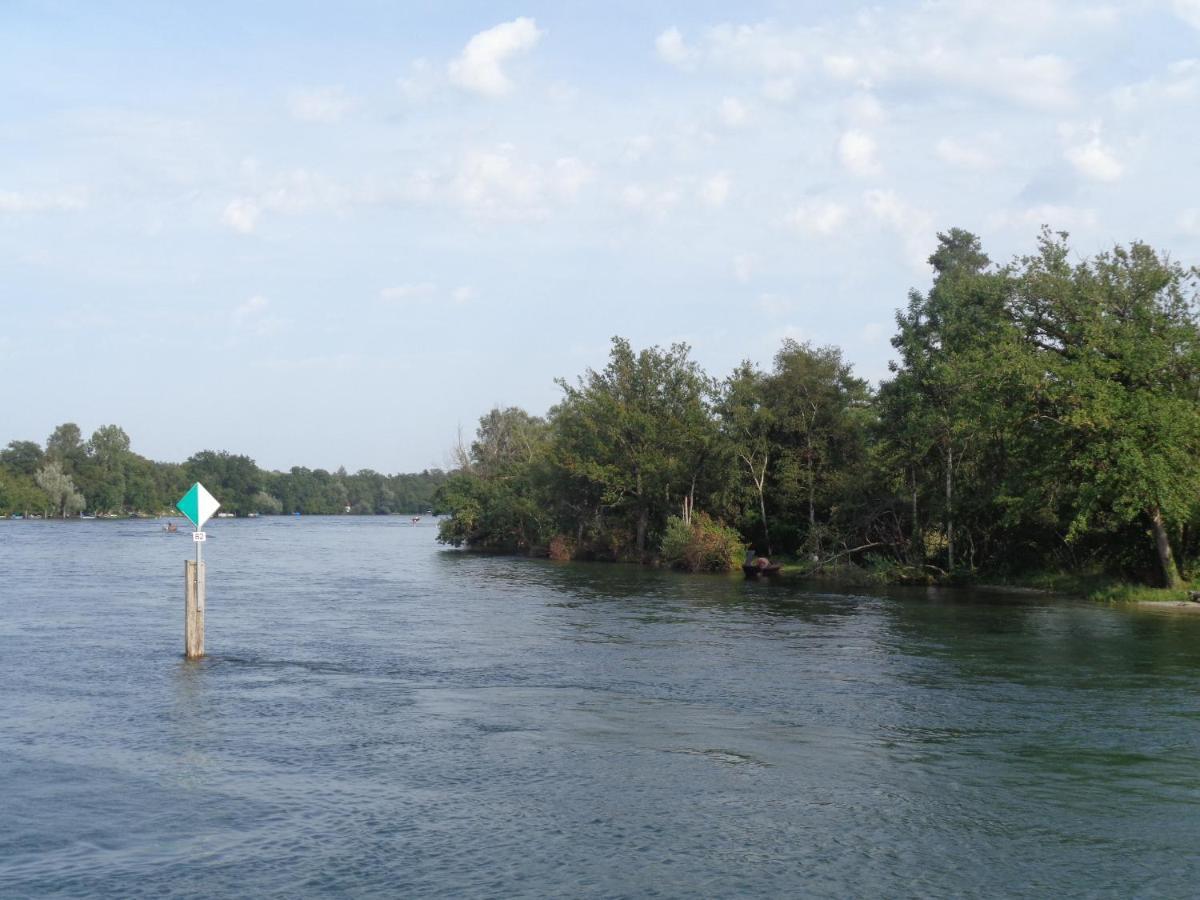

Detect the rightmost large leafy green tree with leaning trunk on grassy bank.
[{"left": 1014, "top": 232, "right": 1200, "bottom": 587}]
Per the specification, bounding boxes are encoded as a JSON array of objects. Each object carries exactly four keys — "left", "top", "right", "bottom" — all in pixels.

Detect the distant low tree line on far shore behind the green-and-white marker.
[{"left": 0, "top": 422, "right": 445, "bottom": 517}]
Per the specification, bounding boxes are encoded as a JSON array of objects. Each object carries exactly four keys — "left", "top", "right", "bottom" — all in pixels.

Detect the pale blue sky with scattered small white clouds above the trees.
[{"left": 0, "top": 0, "right": 1200, "bottom": 472}]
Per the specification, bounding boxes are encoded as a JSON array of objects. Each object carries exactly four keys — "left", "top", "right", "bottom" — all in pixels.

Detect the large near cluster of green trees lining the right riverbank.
[{"left": 438, "top": 229, "right": 1200, "bottom": 586}]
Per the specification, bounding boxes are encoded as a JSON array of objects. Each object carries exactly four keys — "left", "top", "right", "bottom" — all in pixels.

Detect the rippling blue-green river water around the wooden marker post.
[{"left": 0, "top": 517, "right": 1200, "bottom": 898}]
